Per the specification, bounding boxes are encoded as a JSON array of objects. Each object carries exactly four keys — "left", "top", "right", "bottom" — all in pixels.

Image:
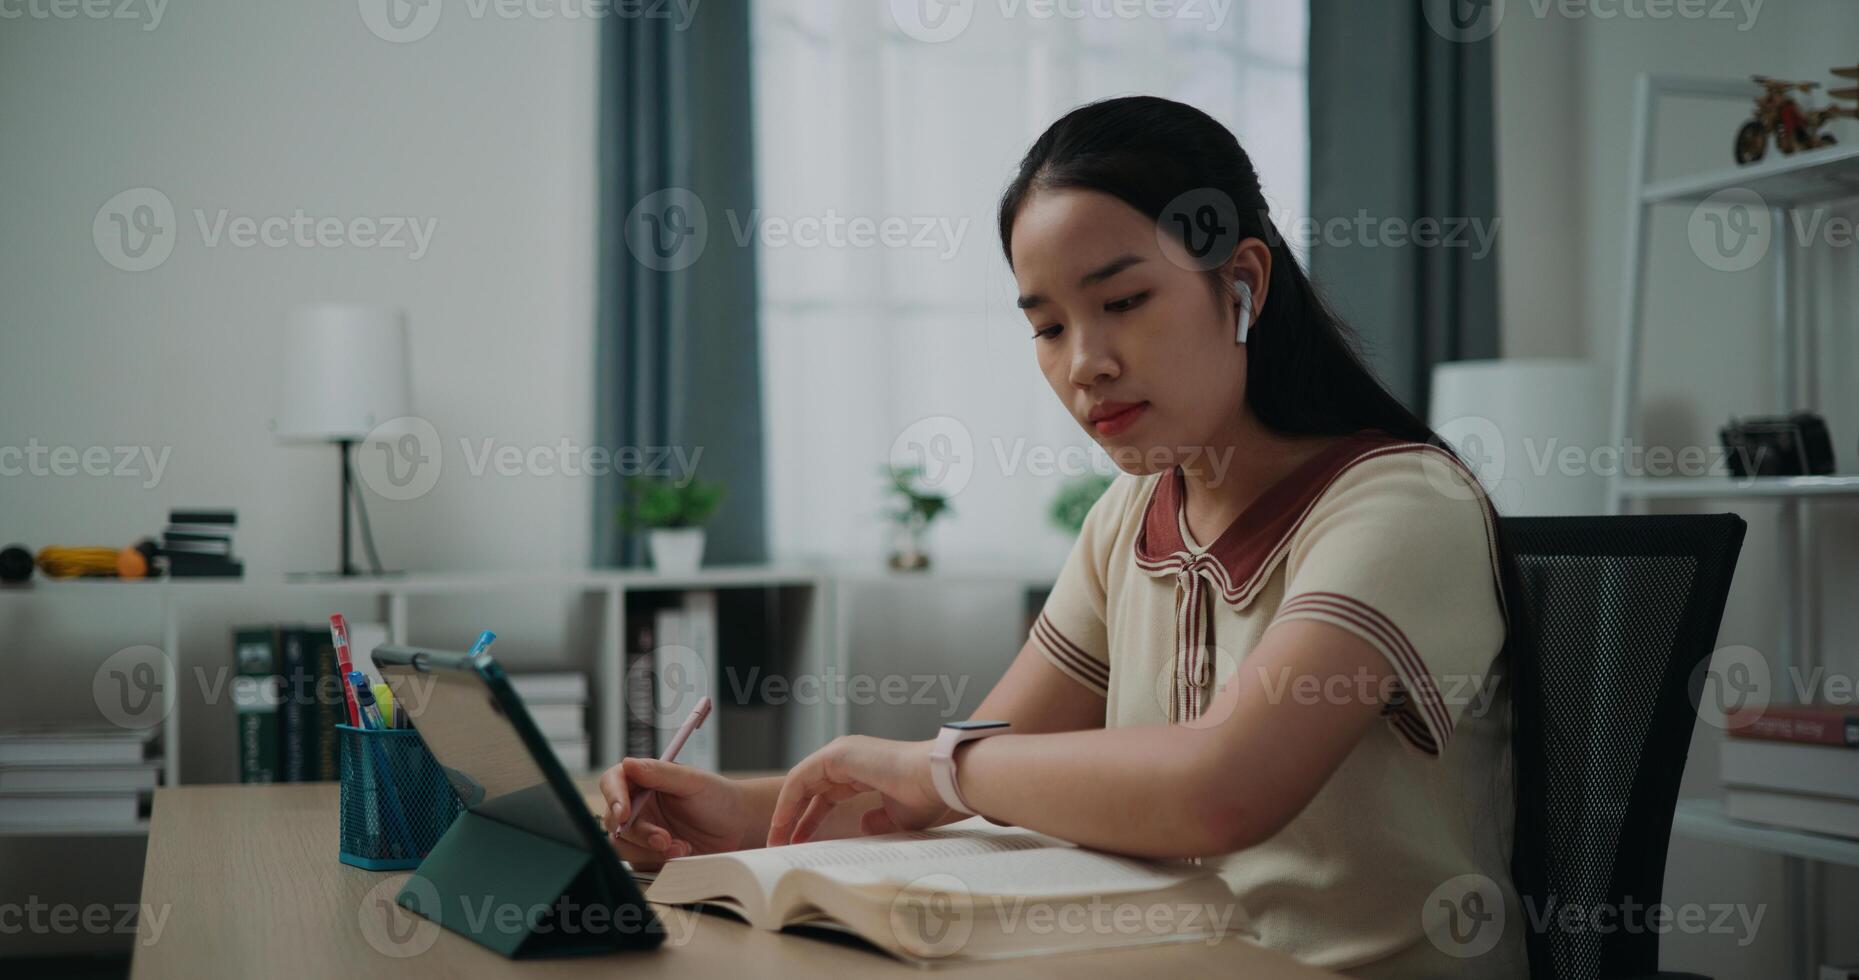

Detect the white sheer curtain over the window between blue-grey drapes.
[{"left": 743, "top": 0, "right": 1309, "bottom": 569}]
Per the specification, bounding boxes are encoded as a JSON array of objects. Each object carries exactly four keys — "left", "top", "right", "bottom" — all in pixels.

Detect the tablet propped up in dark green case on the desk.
[{"left": 374, "top": 645, "right": 664, "bottom": 954}]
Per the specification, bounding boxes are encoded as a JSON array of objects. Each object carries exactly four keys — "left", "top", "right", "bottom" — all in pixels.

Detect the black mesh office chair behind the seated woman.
[{"left": 1502, "top": 513, "right": 1744, "bottom": 980}]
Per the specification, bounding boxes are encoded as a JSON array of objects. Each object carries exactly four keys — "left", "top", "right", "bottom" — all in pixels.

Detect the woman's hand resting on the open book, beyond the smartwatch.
[{"left": 768, "top": 735, "right": 948, "bottom": 846}]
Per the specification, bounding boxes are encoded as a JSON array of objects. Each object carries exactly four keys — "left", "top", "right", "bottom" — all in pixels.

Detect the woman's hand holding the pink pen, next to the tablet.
[{"left": 600, "top": 759, "right": 764, "bottom": 870}]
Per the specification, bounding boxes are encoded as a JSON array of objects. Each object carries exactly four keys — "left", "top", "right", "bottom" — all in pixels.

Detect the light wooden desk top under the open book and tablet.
[{"left": 132, "top": 783, "right": 1335, "bottom": 980}]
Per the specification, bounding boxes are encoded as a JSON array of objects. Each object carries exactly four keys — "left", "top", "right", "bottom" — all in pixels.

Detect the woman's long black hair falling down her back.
[{"left": 1000, "top": 95, "right": 1543, "bottom": 956}]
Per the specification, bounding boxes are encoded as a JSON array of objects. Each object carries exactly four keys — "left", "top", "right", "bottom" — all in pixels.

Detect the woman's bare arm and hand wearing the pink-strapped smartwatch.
[{"left": 768, "top": 621, "right": 1392, "bottom": 857}]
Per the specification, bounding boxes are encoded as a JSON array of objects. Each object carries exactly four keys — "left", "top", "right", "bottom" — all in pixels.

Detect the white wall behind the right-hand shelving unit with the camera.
[{"left": 1496, "top": 0, "right": 1859, "bottom": 978}]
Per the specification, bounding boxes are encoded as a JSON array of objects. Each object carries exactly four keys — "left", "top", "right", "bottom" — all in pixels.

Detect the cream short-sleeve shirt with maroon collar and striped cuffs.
[{"left": 1032, "top": 431, "right": 1528, "bottom": 978}]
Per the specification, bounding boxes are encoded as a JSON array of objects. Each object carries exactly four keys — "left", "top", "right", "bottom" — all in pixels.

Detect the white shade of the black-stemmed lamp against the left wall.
[{"left": 277, "top": 303, "right": 413, "bottom": 443}]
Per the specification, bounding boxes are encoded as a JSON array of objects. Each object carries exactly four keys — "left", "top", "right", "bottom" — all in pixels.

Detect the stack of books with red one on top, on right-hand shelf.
[{"left": 1720, "top": 705, "right": 1859, "bottom": 837}]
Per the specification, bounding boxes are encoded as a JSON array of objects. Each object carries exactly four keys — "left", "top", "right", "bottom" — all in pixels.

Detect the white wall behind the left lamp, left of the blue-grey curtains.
[{"left": 0, "top": 0, "right": 599, "bottom": 954}]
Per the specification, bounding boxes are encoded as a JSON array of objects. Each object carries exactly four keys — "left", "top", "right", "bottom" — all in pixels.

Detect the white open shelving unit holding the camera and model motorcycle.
[{"left": 1608, "top": 74, "right": 1859, "bottom": 976}]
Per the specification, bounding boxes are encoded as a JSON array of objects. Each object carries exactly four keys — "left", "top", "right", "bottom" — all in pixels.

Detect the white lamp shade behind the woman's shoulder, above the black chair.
[{"left": 1428, "top": 359, "right": 1610, "bottom": 517}]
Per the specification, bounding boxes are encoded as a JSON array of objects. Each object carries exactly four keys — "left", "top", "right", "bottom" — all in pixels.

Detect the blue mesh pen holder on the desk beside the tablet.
[{"left": 336, "top": 725, "right": 465, "bottom": 870}]
